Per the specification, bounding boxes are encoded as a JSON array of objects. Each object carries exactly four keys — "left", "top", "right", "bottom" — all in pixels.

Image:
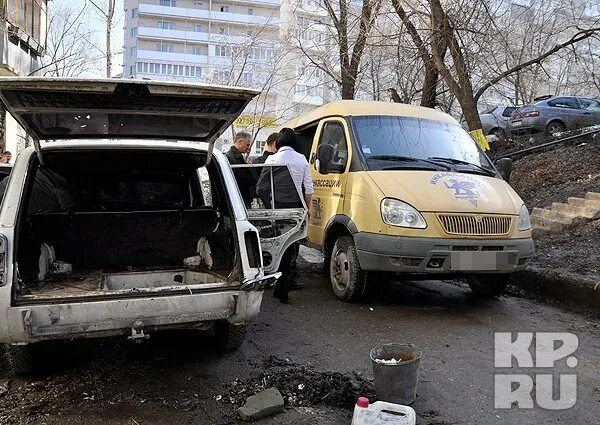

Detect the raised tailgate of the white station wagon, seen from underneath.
[{"left": 0, "top": 77, "right": 258, "bottom": 163}]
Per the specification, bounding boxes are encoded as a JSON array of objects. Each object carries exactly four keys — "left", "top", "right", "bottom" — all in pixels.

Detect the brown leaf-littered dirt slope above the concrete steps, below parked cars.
[{"left": 511, "top": 142, "right": 600, "bottom": 209}]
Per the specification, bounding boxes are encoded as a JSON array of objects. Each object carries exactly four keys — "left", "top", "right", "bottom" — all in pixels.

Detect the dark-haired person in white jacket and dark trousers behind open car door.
[{"left": 265, "top": 128, "right": 314, "bottom": 303}]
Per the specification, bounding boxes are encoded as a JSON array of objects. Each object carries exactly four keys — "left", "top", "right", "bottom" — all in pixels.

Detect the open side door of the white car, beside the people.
[{"left": 231, "top": 164, "right": 308, "bottom": 273}]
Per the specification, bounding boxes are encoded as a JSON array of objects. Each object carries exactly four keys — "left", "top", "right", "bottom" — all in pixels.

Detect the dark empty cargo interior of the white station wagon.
[{"left": 15, "top": 149, "right": 239, "bottom": 302}]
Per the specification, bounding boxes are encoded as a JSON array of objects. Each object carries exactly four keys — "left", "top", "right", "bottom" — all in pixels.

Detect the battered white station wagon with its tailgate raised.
[{"left": 0, "top": 78, "right": 307, "bottom": 372}]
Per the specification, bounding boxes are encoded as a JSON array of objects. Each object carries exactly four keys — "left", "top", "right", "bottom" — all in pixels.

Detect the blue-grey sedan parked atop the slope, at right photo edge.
[{"left": 509, "top": 96, "right": 600, "bottom": 134}]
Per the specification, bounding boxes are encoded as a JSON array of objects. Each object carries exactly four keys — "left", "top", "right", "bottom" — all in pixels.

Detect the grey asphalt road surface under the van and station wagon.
[{"left": 0, "top": 248, "right": 600, "bottom": 425}]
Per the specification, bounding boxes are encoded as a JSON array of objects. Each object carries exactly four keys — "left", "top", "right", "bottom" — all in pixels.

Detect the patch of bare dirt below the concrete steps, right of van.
[{"left": 531, "top": 220, "right": 600, "bottom": 280}]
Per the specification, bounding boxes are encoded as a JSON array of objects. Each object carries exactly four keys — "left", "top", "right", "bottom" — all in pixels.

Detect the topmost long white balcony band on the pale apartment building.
[{"left": 138, "top": 4, "right": 279, "bottom": 27}]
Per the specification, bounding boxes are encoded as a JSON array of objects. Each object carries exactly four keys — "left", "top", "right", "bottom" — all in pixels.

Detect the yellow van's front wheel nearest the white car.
[{"left": 329, "top": 236, "right": 367, "bottom": 301}]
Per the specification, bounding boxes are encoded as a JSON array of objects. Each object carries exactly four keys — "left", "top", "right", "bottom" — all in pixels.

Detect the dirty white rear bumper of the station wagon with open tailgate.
[{"left": 0, "top": 290, "right": 263, "bottom": 343}]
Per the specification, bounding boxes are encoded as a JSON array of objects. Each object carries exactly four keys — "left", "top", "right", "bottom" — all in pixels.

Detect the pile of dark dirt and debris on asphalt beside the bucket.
[{"left": 218, "top": 356, "right": 375, "bottom": 409}]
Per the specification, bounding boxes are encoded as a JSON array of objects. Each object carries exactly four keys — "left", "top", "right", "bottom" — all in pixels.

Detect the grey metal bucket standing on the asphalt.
[{"left": 371, "top": 343, "right": 421, "bottom": 405}]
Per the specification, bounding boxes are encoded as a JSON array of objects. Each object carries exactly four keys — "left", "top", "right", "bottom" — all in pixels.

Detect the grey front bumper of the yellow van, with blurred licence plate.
[{"left": 353, "top": 232, "right": 534, "bottom": 274}]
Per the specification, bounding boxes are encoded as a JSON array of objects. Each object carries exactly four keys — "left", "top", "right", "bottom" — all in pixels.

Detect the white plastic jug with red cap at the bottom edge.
[{"left": 352, "top": 397, "right": 417, "bottom": 425}]
